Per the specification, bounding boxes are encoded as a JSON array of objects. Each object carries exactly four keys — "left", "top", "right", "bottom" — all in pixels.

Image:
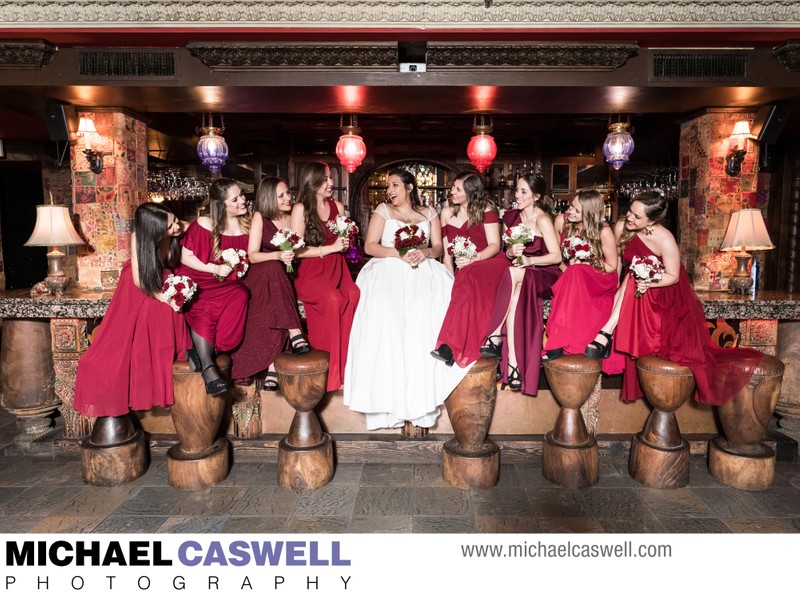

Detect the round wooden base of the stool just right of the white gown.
[{"left": 442, "top": 438, "right": 500, "bottom": 490}]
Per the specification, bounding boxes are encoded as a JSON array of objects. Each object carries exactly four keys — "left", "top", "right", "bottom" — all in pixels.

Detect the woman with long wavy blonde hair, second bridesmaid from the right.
[{"left": 542, "top": 190, "right": 623, "bottom": 374}]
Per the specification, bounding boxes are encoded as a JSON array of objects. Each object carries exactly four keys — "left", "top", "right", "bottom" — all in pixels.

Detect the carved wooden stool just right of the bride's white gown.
[{"left": 442, "top": 357, "right": 500, "bottom": 490}]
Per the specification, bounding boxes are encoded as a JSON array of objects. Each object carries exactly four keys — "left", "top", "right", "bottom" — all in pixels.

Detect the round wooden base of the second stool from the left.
[{"left": 167, "top": 437, "right": 231, "bottom": 491}]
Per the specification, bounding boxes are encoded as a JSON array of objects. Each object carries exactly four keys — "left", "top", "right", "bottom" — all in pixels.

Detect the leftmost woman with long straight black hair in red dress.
[{"left": 75, "top": 203, "right": 192, "bottom": 417}]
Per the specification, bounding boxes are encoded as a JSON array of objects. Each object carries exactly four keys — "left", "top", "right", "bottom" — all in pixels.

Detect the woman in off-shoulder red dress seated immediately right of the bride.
[{"left": 431, "top": 172, "right": 509, "bottom": 368}]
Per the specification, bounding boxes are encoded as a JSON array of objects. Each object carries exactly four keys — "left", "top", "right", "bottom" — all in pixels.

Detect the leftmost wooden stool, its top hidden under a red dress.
[{"left": 81, "top": 415, "right": 147, "bottom": 486}]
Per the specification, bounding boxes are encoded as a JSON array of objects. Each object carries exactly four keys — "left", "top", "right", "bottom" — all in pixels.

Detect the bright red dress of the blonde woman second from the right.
[{"left": 545, "top": 233, "right": 625, "bottom": 374}]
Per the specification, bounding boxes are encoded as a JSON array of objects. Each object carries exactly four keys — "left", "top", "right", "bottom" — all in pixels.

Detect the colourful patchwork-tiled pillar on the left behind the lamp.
[{"left": 71, "top": 110, "right": 147, "bottom": 289}]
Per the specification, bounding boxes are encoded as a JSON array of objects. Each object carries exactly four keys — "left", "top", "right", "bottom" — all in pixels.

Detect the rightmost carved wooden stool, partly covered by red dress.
[{"left": 708, "top": 355, "right": 784, "bottom": 491}]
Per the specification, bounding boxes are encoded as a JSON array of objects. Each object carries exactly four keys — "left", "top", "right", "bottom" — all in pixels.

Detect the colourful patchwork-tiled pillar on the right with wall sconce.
[{"left": 678, "top": 110, "right": 769, "bottom": 290}]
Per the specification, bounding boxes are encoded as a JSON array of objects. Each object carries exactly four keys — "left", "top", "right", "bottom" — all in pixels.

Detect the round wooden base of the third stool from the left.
[{"left": 278, "top": 433, "right": 333, "bottom": 492}]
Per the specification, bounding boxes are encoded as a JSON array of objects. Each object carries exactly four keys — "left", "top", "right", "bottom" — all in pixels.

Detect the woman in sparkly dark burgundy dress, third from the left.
[{"left": 231, "top": 178, "right": 309, "bottom": 391}]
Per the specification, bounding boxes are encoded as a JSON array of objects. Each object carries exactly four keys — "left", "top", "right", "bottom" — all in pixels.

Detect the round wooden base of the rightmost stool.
[{"left": 708, "top": 436, "right": 775, "bottom": 492}]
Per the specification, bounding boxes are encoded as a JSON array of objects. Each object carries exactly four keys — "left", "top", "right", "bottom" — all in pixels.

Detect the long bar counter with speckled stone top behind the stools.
[{"left": 0, "top": 290, "right": 800, "bottom": 461}]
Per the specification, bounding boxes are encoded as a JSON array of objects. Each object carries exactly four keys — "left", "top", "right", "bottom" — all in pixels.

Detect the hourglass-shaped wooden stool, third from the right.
[{"left": 542, "top": 355, "right": 603, "bottom": 488}]
